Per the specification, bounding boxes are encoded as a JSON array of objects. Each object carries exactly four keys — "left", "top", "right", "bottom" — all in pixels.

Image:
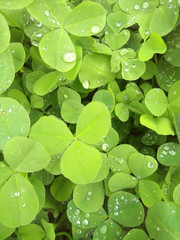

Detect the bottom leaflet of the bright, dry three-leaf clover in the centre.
[{"left": 60, "top": 140, "right": 102, "bottom": 184}]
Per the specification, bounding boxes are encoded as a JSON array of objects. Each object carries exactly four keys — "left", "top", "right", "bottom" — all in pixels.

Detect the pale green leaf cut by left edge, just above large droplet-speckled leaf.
[{"left": 0, "top": 49, "right": 15, "bottom": 93}]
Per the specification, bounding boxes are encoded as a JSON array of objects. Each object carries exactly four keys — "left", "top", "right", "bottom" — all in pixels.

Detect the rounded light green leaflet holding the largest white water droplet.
[{"left": 39, "top": 29, "right": 76, "bottom": 72}]
